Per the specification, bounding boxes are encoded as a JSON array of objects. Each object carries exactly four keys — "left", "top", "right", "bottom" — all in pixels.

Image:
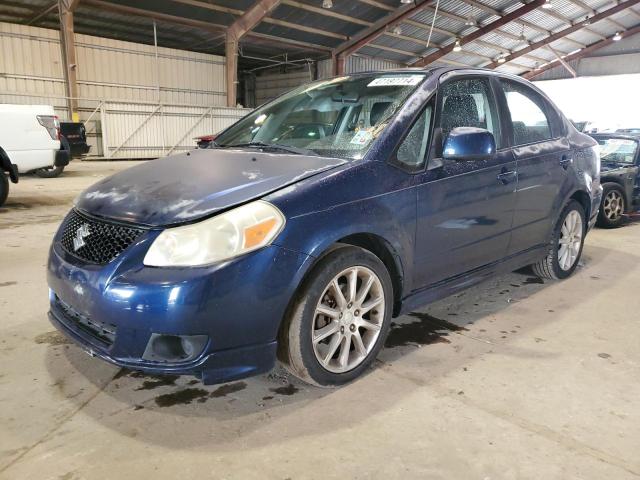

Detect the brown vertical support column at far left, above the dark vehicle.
[{"left": 58, "top": 0, "right": 80, "bottom": 122}]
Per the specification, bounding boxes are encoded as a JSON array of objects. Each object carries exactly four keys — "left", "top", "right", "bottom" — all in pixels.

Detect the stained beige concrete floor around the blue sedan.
[{"left": 0, "top": 162, "right": 640, "bottom": 480}]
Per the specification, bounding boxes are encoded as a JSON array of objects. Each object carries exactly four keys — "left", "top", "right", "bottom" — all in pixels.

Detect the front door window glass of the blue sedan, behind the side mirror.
[{"left": 440, "top": 78, "right": 500, "bottom": 148}]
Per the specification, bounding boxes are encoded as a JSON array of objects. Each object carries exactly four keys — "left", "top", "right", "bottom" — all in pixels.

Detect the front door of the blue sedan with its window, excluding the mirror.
[{"left": 414, "top": 76, "right": 517, "bottom": 289}]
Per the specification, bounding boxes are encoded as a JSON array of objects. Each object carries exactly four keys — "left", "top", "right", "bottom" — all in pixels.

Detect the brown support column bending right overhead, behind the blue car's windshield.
[{"left": 224, "top": 0, "right": 280, "bottom": 107}]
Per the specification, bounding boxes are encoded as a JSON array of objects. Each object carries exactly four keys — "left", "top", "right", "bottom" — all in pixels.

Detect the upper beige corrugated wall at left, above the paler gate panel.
[{"left": 0, "top": 23, "right": 226, "bottom": 106}]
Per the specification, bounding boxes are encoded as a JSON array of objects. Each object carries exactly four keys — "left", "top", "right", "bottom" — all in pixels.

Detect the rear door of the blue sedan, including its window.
[{"left": 497, "top": 78, "right": 573, "bottom": 254}]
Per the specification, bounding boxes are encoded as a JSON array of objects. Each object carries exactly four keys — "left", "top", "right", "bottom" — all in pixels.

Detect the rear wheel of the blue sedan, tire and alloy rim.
[{"left": 532, "top": 200, "right": 587, "bottom": 280}]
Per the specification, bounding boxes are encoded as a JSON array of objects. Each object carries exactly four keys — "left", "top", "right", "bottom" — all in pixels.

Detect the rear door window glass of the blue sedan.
[{"left": 500, "top": 80, "right": 553, "bottom": 146}]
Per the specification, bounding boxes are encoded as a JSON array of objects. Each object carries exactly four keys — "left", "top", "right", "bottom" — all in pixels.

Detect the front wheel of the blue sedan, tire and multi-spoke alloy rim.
[{"left": 278, "top": 245, "right": 394, "bottom": 387}]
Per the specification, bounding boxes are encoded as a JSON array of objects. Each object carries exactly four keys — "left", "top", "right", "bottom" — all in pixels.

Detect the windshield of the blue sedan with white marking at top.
[{"left": 216, "top": 72, "right": 426, "bottom": 159}]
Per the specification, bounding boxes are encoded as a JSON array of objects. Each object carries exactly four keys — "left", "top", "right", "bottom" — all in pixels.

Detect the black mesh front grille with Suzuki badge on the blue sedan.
[{"left": 60, "top": 210, "right": 144, "bottom": 265}]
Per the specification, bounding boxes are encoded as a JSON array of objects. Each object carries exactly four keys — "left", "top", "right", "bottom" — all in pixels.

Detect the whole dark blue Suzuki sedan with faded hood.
[{"left": 48, "top": 68, "right": 602, "bottom": 386}]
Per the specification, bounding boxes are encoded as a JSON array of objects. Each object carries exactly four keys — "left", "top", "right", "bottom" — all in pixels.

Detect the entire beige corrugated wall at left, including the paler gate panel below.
[{"left": 0, "top": 22, "right": 242, "bottom": 158}]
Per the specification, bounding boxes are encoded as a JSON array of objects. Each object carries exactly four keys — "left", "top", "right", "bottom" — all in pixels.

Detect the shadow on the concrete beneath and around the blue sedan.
[{"left": 41, "top": 247, "right": 636, "bottom": 448}]
